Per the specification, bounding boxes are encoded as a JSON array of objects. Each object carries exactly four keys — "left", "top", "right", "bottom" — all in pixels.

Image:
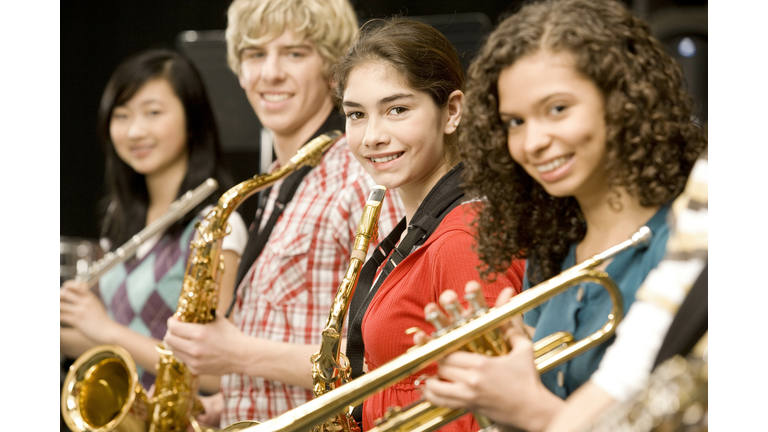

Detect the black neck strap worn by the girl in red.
[{"left": 347, "top": 163, "right": 464, "bottom": 379}]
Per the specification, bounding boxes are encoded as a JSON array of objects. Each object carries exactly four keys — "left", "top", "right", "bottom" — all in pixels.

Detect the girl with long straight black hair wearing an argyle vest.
[{"left": 60, "top": 50, "right": 247, "bottom": 387}]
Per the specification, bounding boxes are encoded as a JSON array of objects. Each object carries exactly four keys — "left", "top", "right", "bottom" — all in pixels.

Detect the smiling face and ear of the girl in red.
[{"left": 342, "top": 63, "right": 463, "bottom": 208}]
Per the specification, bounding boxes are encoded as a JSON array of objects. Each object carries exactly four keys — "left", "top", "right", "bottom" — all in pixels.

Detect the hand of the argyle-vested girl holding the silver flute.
[{"left": 59, "top": 280, "right": 118, "bottom": 344}]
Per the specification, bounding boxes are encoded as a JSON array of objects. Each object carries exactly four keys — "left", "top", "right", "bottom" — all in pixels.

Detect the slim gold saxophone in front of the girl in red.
[{"left": 222, "top": 185, "right": 387, "bottom": 432}]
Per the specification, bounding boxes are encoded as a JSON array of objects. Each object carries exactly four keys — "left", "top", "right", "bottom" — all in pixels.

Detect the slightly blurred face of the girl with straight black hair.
[{"left": 109, "top": 78, "right": 188, "bottom": 177}]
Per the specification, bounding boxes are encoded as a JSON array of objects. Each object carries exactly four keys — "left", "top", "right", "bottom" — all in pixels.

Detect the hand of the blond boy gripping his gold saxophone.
[{"left": 163, "top": 315, "right": 247, "bottom": 375}]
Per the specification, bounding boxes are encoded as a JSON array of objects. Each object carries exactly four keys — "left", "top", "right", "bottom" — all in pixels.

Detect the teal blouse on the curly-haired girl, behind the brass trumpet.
[{"left": 523, "top": 205, "right": 669, "bottom": 399}]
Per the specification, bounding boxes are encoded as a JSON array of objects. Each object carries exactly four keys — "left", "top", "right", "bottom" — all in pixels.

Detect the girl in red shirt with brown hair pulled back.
[{"left": 333, "top": 19, "right": 523, "bottom": 431}]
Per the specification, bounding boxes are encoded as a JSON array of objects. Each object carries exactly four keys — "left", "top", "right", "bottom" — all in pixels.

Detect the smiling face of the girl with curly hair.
[{"left": 498, "top": 51, "right": 607, "bottom": 200}]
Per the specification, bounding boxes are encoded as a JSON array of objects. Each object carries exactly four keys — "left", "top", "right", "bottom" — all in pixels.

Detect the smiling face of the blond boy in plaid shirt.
[{"left": 239, "top": 29, "right": 333, "bottom": 144}]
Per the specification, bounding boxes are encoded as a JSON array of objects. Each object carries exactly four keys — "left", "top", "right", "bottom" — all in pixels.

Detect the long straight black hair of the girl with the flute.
[{"left": 97, "top": 50, "right": 234, "bottom": 249}]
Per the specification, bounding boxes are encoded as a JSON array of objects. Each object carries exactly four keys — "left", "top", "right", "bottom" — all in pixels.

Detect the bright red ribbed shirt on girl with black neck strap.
[{"left": 362, "top": 202, "right": 525, "bottom": 432}]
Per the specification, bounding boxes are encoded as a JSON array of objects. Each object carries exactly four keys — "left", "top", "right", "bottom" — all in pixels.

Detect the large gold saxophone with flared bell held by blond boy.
[{"left": 61, "top": 131, "right": 342, "bottom": 432}]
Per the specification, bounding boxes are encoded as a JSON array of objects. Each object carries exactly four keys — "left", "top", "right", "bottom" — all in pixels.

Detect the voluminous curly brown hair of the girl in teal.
[{"left": 459, "top": 0, "right": 707, "bottom": 283}]
